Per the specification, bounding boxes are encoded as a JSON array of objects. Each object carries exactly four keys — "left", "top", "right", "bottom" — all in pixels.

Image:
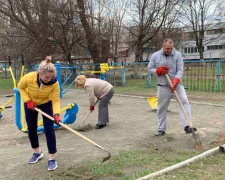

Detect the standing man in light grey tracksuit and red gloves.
[{"left": 148, "top": 38, "right": 195, "bottom": 136}]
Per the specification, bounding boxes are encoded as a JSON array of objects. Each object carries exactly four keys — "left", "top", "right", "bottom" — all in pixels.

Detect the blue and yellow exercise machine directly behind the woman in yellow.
[{"left": 10, "top": 55, "right": 78, "bottom": 133}]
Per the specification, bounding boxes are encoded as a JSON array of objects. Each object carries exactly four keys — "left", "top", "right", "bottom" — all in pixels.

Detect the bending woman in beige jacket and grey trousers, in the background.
[{"left": 75, "top": 75, "right": 114, "bottom": 129}]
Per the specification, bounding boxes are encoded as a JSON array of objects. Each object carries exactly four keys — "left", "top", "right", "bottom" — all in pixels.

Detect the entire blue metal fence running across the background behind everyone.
[{"left": 0, "top": 59, "right": 225, "bottom": 92}]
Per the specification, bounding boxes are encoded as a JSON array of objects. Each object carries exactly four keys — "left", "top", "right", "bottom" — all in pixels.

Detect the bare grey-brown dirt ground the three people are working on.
[{"left": 0, "top": 90, "right": 225, "bottom": 180}]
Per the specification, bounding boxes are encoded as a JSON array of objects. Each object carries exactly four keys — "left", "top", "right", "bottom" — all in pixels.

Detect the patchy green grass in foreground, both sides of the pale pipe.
[{"left": 44, "top": 148, "right": 225, "bottom": 180}]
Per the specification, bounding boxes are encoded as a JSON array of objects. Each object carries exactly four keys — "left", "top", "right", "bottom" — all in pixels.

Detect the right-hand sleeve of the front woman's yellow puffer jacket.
[{"left": 52, "top": 81, "right": 60, "bottom": 114}]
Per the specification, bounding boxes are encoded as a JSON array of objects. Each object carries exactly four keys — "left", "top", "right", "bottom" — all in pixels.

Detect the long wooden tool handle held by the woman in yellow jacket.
[{"left": 34, "top": 107, "right": 108, "bottom": 152}]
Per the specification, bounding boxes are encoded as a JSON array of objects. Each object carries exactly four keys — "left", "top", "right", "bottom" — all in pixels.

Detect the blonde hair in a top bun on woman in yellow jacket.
[{"left": 37, "top": 56, "right": 56, "bottom": 77}]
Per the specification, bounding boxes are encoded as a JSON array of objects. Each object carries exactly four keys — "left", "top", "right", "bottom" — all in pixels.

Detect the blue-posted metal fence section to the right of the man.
[{"left": 182, "top": 59, "right": 225, "bottom": 92}]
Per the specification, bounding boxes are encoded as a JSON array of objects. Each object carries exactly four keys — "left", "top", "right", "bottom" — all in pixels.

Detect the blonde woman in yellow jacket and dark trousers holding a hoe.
[{"left": 18, "top": 56, "right": 61, "bottom": 170}]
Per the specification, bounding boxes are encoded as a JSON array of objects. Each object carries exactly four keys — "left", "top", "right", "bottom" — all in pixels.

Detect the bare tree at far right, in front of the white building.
[{"left": 179, "top": 0, "right": 224, "bottom": 59}]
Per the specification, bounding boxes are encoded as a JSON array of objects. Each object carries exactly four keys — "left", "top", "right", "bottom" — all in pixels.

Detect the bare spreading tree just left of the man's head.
[{"left": 125, "top": 0, "right": 180, "bottom": 62}]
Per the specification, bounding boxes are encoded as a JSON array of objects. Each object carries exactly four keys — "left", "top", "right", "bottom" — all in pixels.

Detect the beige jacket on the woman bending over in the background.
[{"left": 84, "top": 78, "right": 113, "bottom": 106}]
